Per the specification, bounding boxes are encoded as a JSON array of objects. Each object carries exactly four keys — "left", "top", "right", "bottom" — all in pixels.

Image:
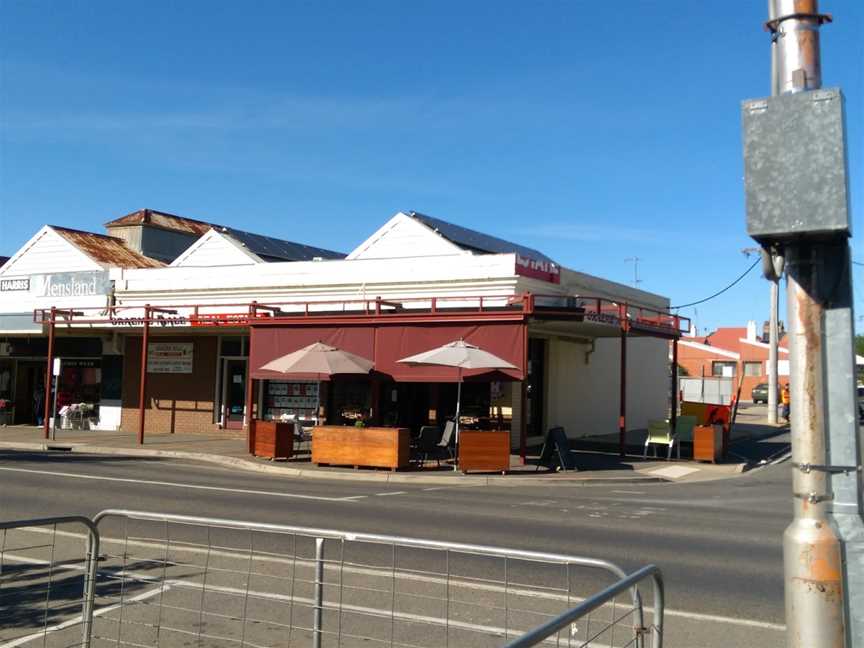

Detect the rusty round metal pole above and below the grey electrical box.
[{"left": 769, "top": 0, "right": 851, "bottom": 648}]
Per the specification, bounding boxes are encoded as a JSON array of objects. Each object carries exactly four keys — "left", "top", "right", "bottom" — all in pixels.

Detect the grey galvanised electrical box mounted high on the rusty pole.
[{"left": 742, "top": 88, "right": 851, "bottom": 243}]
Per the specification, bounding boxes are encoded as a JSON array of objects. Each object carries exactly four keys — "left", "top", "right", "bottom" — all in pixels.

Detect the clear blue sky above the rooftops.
[{"left": 0, "top": 0, "right": 864, "bottom": 329}]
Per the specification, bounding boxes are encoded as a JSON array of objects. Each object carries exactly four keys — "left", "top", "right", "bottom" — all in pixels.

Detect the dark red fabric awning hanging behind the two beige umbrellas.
[{"left": 249, "top": 322, "right": 525, "bottom": 382}]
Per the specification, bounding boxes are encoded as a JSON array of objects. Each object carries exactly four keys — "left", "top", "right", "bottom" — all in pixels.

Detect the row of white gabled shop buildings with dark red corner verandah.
[{"left": 0, "top": 210, "right": 686, "bottom": 452}]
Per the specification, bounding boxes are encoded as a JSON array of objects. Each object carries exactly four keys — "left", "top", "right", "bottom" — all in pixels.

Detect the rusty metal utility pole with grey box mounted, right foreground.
[{"left": 742, "top": 0, "right": 864, "bottom": 648}]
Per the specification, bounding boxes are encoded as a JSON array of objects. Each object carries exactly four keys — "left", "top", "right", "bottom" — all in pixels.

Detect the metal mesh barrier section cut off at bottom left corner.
[{"left": 0, "top": 516, "right": 99, "bottom": 648}]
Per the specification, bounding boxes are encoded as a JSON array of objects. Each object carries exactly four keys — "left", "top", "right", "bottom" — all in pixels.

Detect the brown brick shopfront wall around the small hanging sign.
[{"left": 120, "top": 336, "right": 218, "bottom": 434}]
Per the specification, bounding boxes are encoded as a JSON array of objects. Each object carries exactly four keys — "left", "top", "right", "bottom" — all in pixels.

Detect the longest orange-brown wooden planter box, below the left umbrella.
[{"left": 312, "top": 425, "right": 410, "bottom": 470}]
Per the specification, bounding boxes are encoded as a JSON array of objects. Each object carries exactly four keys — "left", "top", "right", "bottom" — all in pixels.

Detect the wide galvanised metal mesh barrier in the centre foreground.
[{"left": 0, "top": 510, "right": 663, "bottom": 648}]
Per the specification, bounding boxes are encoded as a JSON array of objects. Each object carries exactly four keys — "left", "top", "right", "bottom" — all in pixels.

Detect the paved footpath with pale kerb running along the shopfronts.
[{"left": 0, "top": 404, "right": 788, "bottom": 486}]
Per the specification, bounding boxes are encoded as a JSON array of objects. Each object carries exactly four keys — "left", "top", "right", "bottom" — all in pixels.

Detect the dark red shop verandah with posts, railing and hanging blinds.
[{"left": 36, "top": 293, "right": 688, "bottom": 458}]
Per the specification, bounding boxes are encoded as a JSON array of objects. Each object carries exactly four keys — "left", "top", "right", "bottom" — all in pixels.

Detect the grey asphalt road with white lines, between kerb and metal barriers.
[{"left": 0, "top": 452, "right": 792, "bottom": 648}]
